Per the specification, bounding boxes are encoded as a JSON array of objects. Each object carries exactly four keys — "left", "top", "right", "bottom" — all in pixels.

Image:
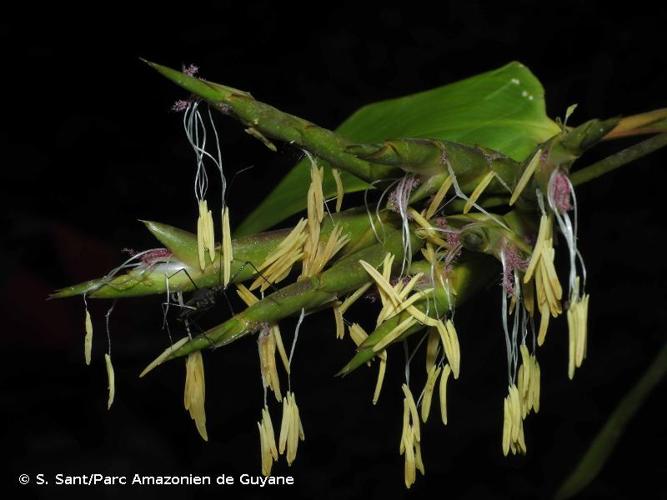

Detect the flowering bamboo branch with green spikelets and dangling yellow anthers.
[{"left": 53, "top": 63, "right": 667, "bottom": 488}]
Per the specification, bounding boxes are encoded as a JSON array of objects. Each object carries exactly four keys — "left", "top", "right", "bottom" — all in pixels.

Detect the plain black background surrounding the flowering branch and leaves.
[{"left": 0, "top": 2, "right": 667, "bottom": 498}]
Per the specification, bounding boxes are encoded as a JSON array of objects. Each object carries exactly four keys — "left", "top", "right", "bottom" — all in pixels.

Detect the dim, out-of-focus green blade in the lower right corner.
[{"left": 556, "top": 344, "right": 667, "bottom": 500}]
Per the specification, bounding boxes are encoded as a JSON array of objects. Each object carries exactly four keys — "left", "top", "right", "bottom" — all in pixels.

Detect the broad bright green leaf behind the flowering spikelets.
[{"left": 236, "top": 62, "right": 560, "bottom": 235}]
